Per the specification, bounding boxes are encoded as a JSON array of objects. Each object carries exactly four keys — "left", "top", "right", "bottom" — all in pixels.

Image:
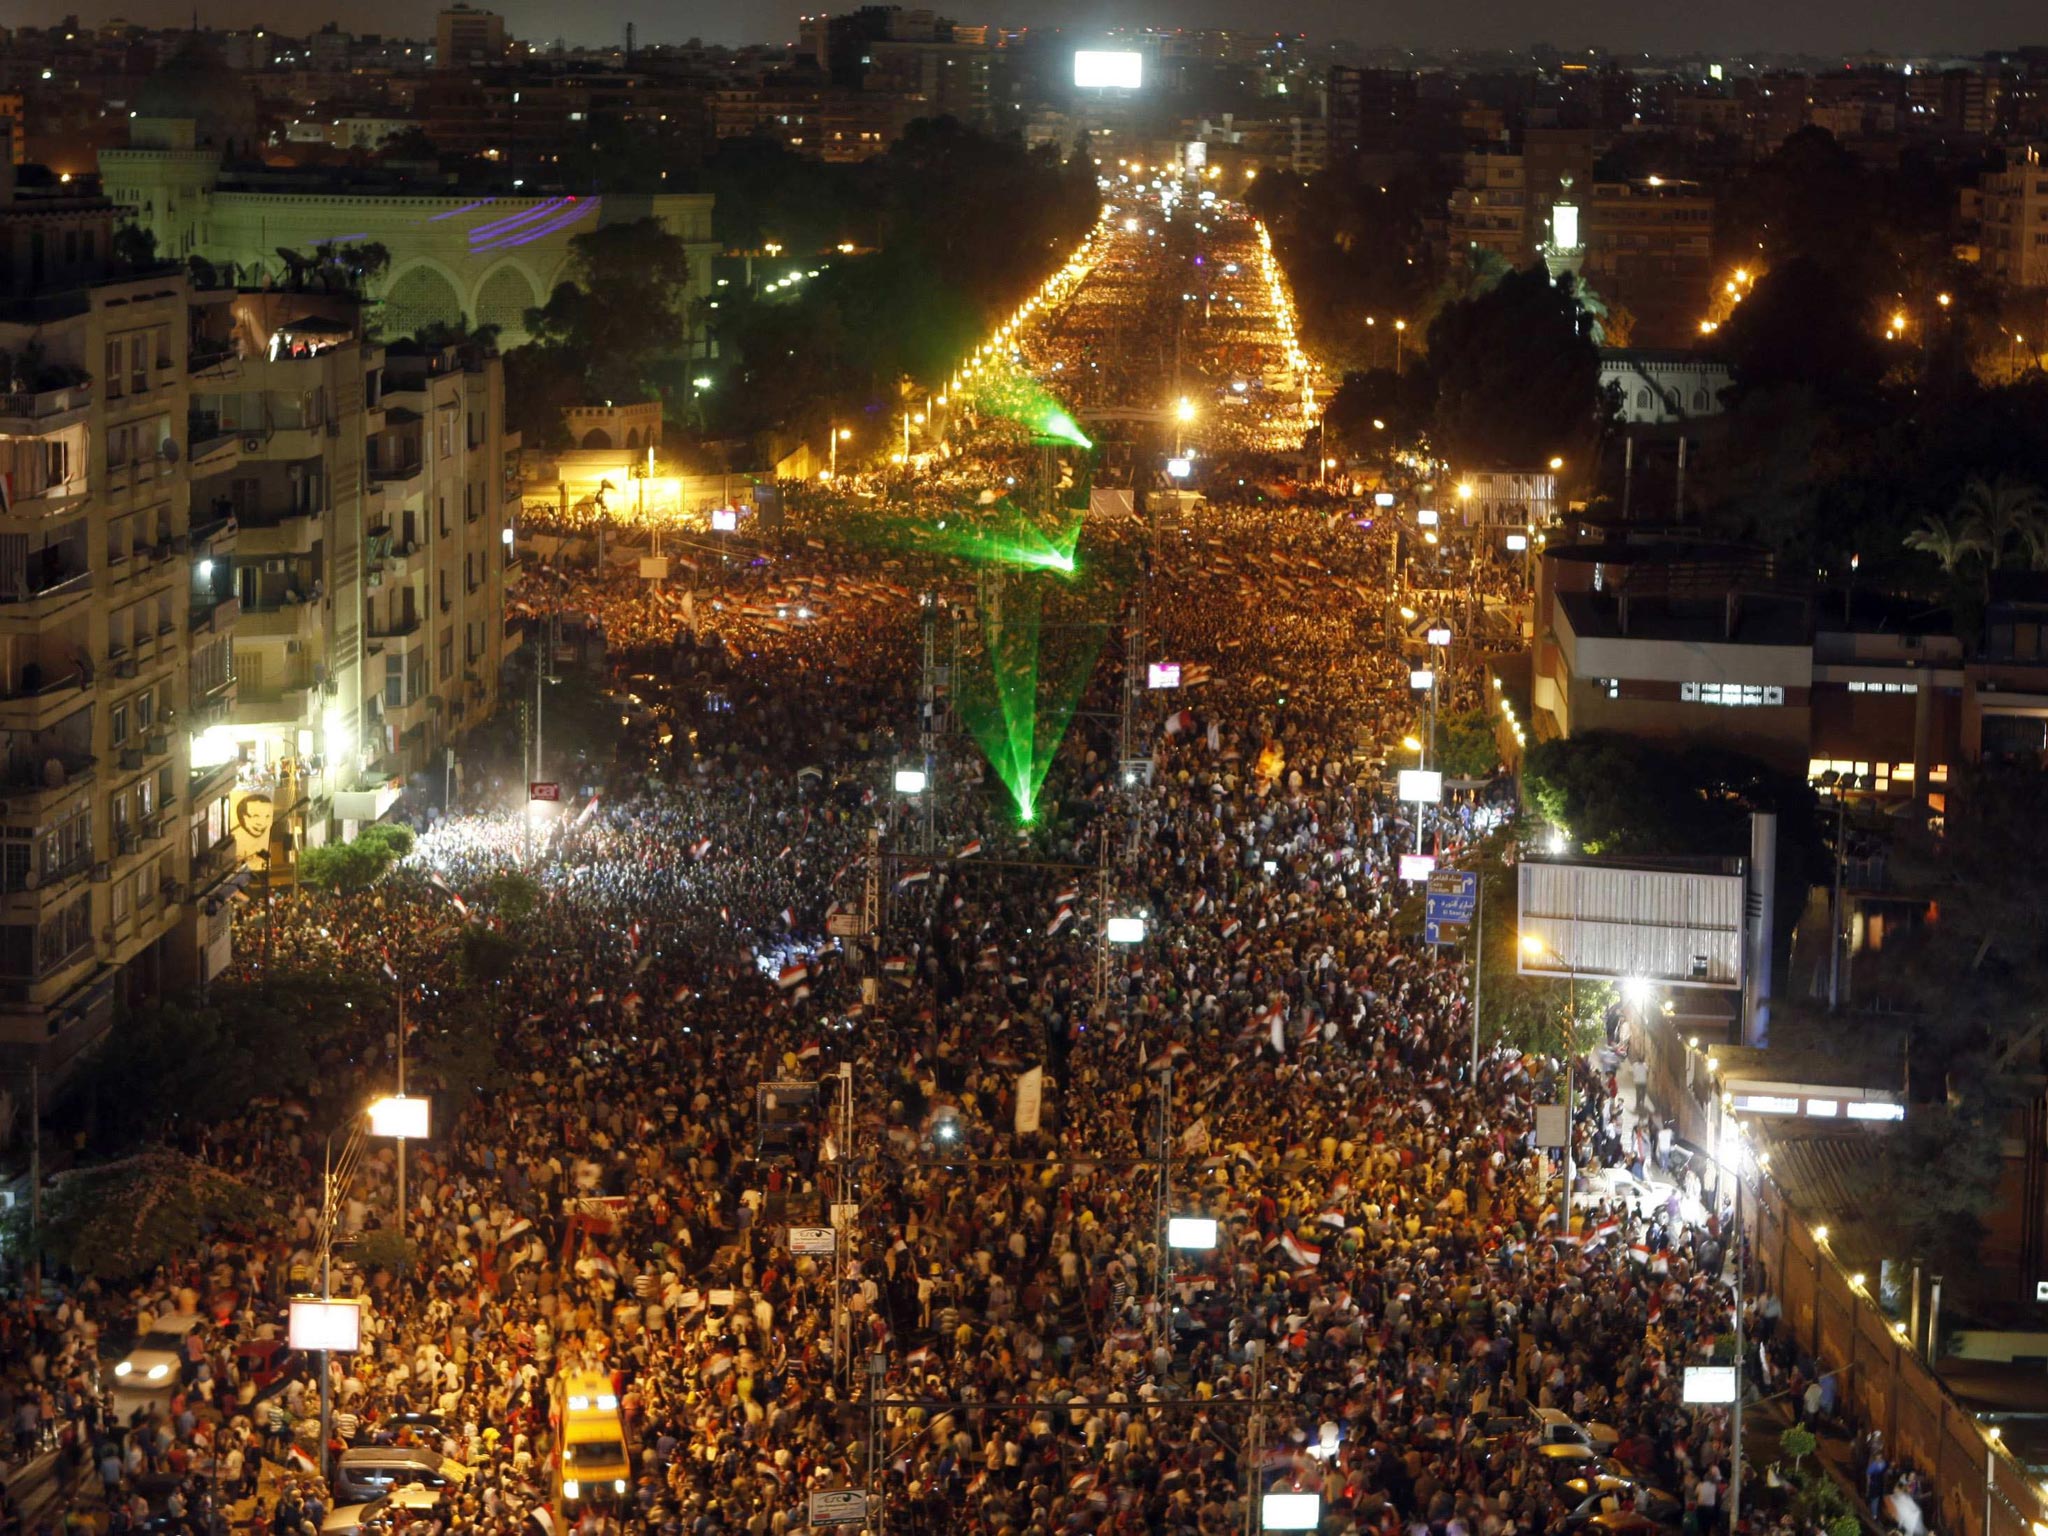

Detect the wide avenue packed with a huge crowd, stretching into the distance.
[{"left": 6, "top": 183, "right": 1931, "bottom": 1536}]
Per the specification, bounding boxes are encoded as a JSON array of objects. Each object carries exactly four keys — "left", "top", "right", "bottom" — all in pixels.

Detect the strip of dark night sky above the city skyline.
[{"left": 14, "top": 0, "right": 2048, "bottom": 55}]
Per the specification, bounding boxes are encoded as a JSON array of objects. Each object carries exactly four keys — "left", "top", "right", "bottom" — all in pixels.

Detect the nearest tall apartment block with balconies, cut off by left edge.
[{"left": 0, "top": 160, "right": 236, "bottom": 1079}]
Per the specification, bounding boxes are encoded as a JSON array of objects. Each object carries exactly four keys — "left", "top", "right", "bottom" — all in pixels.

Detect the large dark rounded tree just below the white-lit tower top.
[{"left": 1430, "top": 264, "right": 1602, "bottom": 467}]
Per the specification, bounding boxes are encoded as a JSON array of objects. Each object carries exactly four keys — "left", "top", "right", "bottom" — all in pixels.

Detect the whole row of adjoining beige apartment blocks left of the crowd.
[{"left": 0, "top": 162, "right": 518, "bottom": 1083}]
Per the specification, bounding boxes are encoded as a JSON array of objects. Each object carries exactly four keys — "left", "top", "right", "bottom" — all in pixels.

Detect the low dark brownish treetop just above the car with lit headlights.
[{"left": 6, "top": 1147, "right": 272, "bottom": 1282}]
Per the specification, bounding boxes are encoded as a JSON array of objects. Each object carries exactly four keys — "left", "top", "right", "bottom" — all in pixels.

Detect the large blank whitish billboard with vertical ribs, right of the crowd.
[{"left": 1516, "top": 858, "right": 1745, "bottom": 987}]
